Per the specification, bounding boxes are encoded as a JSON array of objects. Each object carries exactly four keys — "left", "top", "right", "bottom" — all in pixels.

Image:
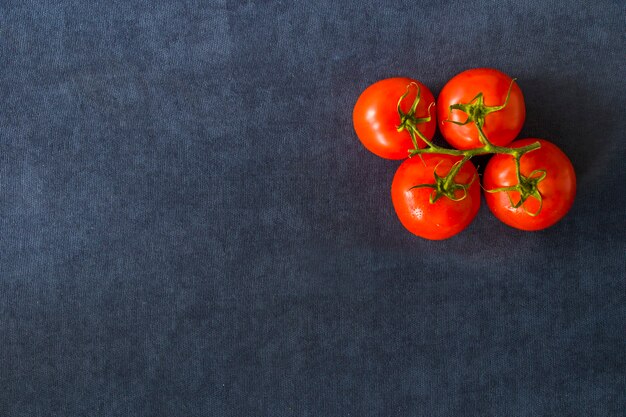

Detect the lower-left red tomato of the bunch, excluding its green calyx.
[{"left": 391, "top": 154, "right": 480, "bottom": 240}]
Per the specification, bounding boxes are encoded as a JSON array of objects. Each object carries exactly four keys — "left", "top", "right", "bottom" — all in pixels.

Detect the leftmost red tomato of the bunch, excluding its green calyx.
[{"left": 352, "top": 77, "right": 437, "bottom": 159}]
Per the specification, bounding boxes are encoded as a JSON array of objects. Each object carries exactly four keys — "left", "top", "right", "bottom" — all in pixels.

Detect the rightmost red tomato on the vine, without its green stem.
[{"left": 483, "top": 138, "right": 576, "bottom": 230}]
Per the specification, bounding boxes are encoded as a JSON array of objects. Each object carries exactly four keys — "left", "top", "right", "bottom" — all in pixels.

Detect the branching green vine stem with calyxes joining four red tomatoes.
[{"left": 398, "top": 79, "right": 548, "bottom": 216}]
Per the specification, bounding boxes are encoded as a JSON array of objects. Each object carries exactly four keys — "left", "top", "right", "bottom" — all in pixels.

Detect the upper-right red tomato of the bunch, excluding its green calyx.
[{"left": 437, "top": 68, "right": 526, "bottom": 149}]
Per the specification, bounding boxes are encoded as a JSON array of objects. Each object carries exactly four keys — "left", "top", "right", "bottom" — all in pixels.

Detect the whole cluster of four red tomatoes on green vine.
[{"left": 353, "top": 68, "right": 576, "bottom": 240}]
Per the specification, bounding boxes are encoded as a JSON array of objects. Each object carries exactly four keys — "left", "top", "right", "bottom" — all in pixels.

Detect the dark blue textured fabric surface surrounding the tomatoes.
[{"left": 0, "top": 0, "right": 626, "bottom": 417}]
